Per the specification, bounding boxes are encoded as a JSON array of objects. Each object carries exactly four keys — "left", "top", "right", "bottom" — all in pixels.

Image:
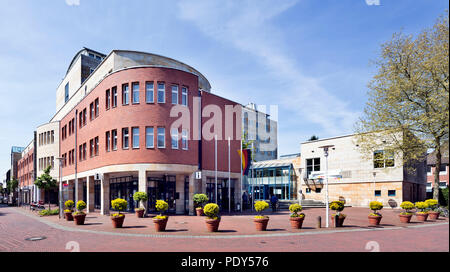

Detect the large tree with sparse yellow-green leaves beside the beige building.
[{"left": 356, "top": 11, "right": 449, "bottom": 200}]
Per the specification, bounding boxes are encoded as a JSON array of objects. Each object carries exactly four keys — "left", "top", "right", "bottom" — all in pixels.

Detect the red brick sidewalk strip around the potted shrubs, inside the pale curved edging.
[{"left": 16, "top": 207, "right": 448, "bottom": 238}]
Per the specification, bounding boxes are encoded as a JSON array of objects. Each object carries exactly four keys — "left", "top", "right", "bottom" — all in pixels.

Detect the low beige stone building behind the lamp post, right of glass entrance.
[{"left": 299, "top": 135, "right": 426, "bottom": 207}]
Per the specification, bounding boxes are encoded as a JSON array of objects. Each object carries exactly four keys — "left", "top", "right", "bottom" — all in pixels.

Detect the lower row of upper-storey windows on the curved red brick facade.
[{"left": 62, "top": 127, "right": 189, "bottom": 167}]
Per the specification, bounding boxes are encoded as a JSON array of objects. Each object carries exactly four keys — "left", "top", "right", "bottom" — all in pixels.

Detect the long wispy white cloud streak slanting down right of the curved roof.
[{"left": 178, "top": 0, "right": 359, "bottom": 135}]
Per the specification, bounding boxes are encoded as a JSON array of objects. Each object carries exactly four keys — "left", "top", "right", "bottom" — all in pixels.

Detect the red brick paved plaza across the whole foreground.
[{"left": 0, "top": 206, "right": 449, "bottom": 252}]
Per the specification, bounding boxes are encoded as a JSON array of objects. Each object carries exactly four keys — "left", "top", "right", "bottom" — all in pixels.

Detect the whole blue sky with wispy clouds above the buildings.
[{"left": 0, "top": 0, "right": 448, "bottom": 181}]
